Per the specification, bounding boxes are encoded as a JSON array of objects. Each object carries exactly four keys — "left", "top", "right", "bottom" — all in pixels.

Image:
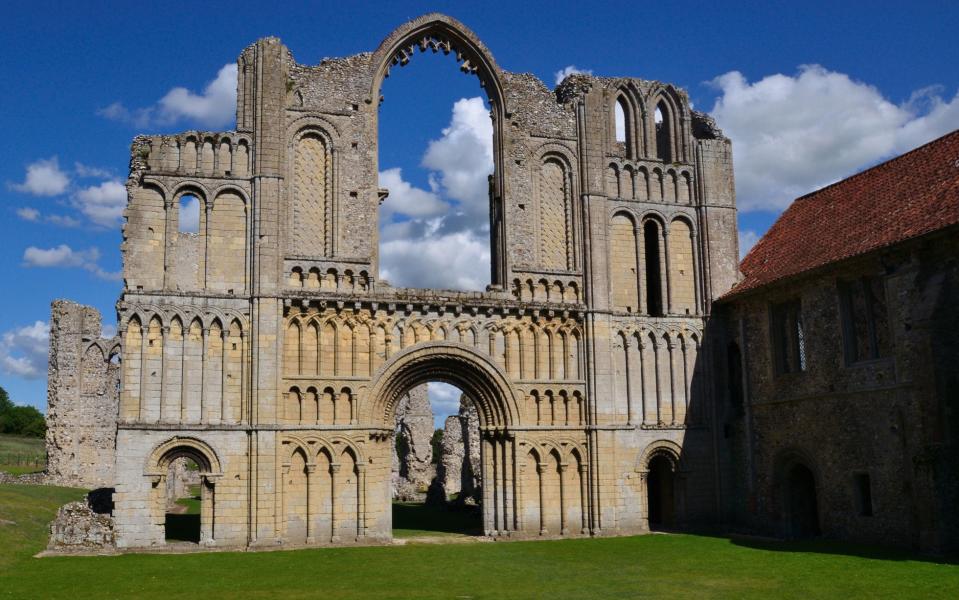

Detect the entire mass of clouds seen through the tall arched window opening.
[{"left": 380, "top": 97, "right": 493, "bottom": 290}]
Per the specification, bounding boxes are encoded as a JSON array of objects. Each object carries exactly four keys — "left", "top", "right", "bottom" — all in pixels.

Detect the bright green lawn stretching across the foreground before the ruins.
[{"left": 0, "top": 485, "right": 959, "bottom": 600}]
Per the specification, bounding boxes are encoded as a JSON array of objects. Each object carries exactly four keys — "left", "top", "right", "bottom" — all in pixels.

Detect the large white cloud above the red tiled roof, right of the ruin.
[{"left": 712, "top": 65, "right": 959, "bottom": 211}]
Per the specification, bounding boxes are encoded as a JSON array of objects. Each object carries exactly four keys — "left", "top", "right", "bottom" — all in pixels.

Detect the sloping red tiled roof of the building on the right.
[{"left": 726, "top": 130, "right": 959, "bottom": 297}]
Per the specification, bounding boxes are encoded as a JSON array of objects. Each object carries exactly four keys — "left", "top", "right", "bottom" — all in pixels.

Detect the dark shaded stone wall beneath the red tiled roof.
[{"left": 719, "top": 234, "right": 959, "bottom": 550}]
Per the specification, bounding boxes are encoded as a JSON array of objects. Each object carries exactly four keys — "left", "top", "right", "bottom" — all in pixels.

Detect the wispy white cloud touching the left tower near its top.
[{"left": 97, "top": 63, "right": 237, "bottom": 128}]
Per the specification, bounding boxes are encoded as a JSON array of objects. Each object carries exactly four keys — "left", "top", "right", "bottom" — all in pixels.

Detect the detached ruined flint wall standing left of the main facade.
[{"left": 46, "top": 300, "right": 120, "bottom": 488}]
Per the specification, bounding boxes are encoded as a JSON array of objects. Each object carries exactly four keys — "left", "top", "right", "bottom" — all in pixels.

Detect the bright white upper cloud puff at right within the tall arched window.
[{"left": 422, "top": 97, "right": 493, "bottom": 215}]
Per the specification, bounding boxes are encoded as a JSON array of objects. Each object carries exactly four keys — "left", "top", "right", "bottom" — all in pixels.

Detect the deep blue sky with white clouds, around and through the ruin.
[{"left": 0, "top": 1, "right": 959, "bottom": 424}]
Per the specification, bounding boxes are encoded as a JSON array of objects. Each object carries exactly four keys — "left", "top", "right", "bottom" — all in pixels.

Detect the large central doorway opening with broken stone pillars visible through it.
[{"left": 391, "top": 382, "right": 483, "bottom": 538}]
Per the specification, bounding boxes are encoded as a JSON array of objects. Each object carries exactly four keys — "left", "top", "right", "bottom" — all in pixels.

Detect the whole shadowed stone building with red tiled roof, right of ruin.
[{"left": 715, "top": 131, "right": 959, "bottom": 551}]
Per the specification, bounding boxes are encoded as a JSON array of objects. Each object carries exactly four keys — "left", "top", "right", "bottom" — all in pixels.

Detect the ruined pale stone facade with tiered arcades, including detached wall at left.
[{"left": 50, "top": 14, "right": 738, "bottom": 548}]
